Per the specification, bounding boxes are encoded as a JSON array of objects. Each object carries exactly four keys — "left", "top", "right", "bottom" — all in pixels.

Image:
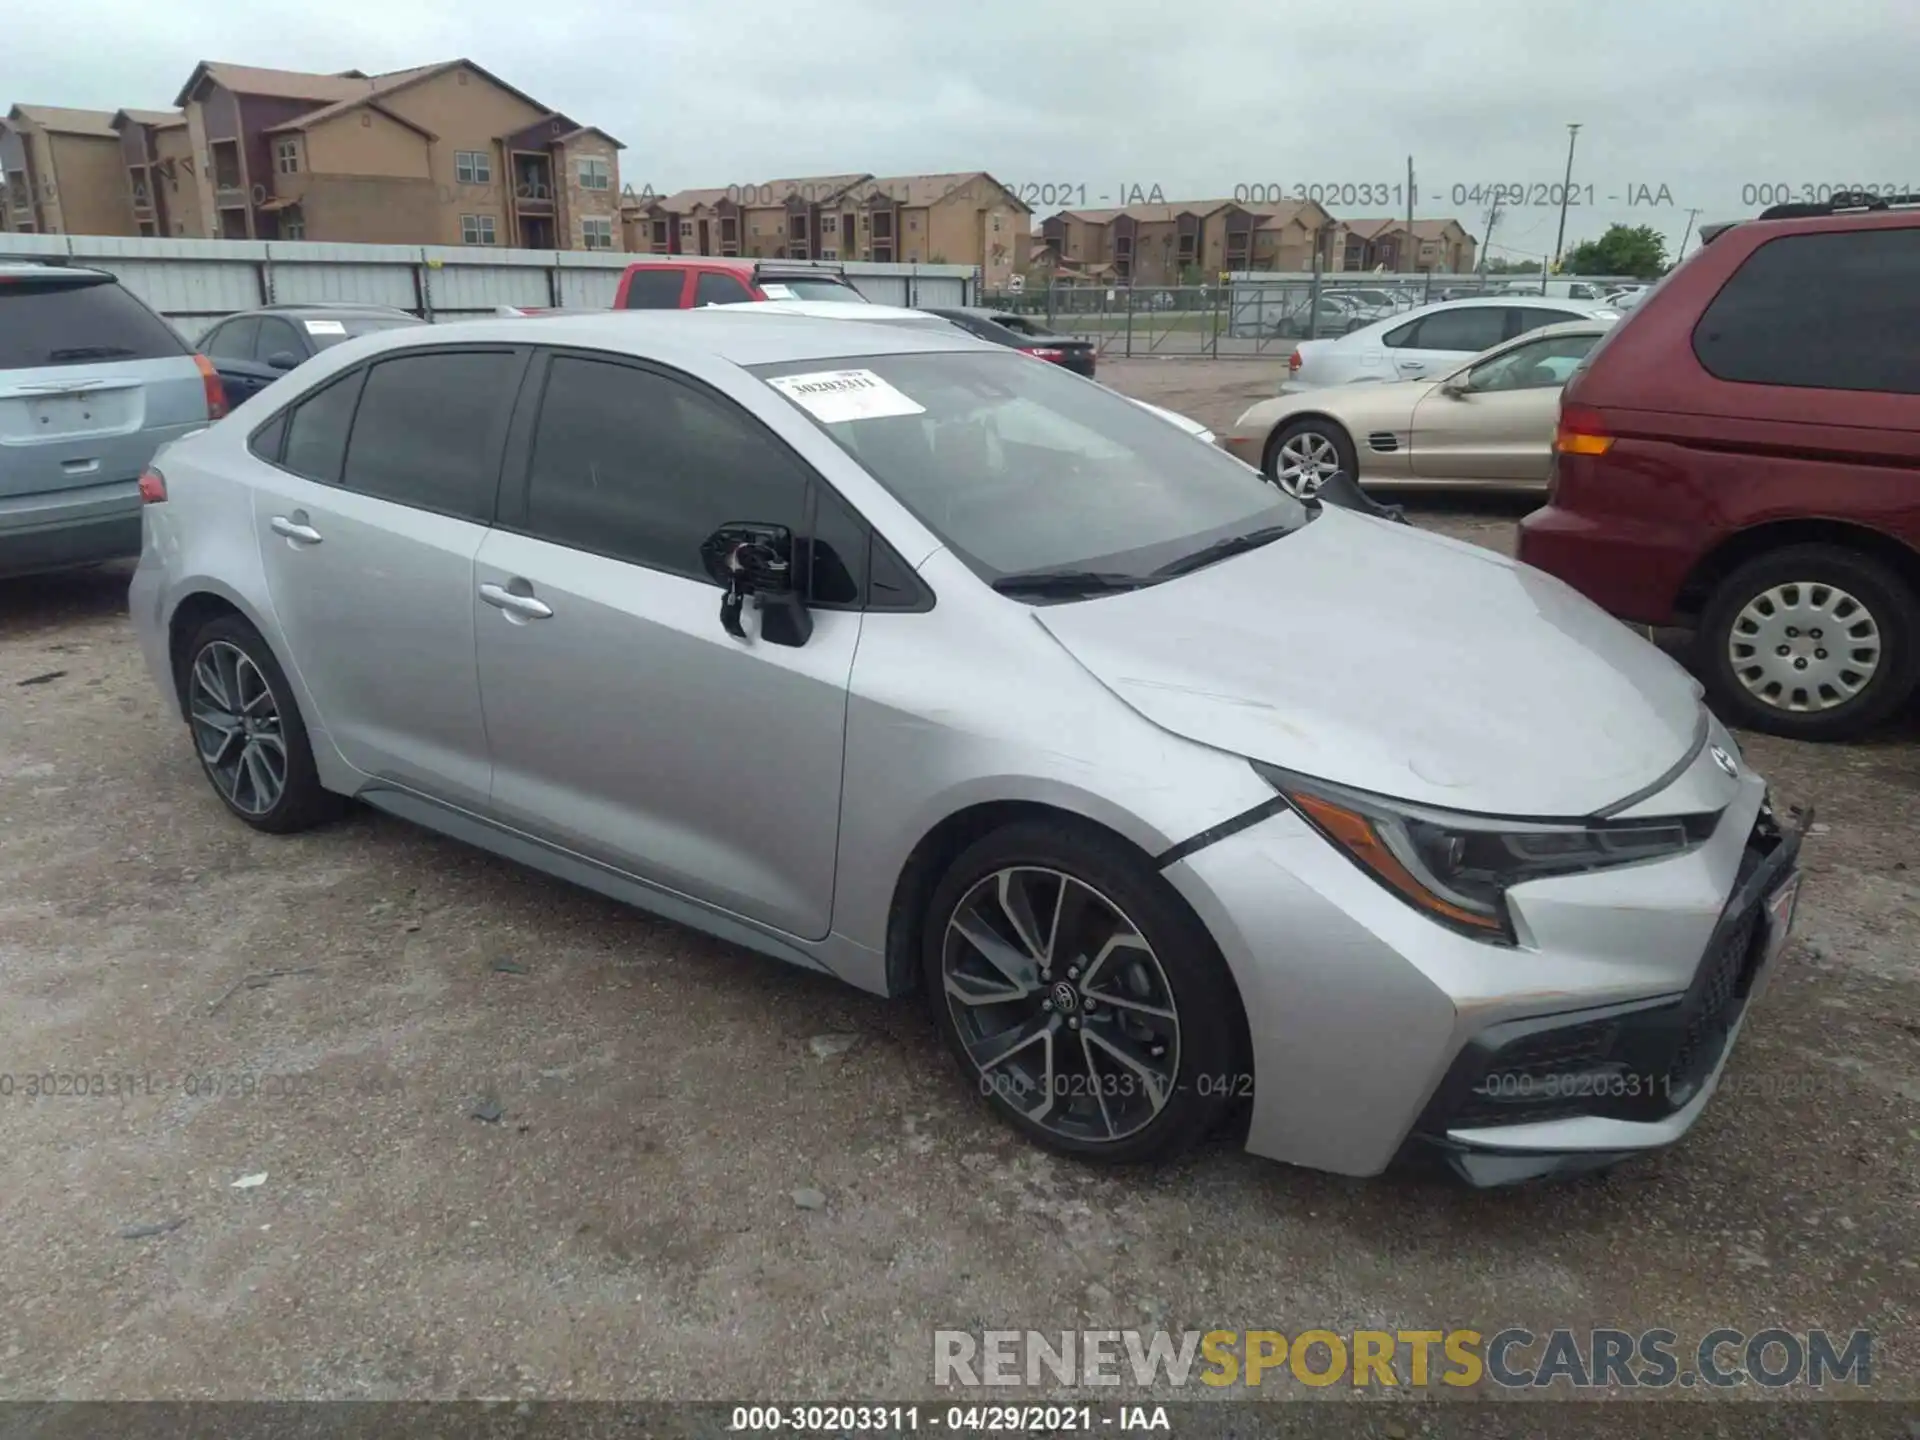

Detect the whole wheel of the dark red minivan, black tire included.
[{"left": 1695, "top": 545, "right": 1920, "bottom": 741}]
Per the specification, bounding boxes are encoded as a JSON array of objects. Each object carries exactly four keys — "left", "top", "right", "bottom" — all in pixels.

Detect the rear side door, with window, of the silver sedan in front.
[{"left": 253, "top": 348, "right": 526, "bottom": 810}]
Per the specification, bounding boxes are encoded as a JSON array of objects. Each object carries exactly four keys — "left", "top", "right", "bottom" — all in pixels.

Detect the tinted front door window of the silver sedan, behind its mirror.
[{"left": 526, "top": 355, "right": 806, "bottom": 580}]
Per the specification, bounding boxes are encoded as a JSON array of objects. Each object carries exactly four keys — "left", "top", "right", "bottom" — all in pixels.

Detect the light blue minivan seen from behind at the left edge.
[{"left": 0, "top": 261, "right": 227, "bottom": 576}]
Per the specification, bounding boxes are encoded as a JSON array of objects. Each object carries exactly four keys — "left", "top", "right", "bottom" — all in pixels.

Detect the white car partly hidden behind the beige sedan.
[{"left": 1281, "top": 296, "right": 1620, "bottom": 396}]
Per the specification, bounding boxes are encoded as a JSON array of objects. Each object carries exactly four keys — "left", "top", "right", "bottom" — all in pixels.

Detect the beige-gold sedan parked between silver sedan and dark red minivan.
[{"left": 1221, "top": 319, "right": 1613, "bottom": 499}]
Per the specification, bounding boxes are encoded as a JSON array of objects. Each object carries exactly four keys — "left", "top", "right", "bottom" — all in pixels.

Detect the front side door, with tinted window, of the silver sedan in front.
[{"left": 470, "top": 353, "right": 860, "bottom": 939}]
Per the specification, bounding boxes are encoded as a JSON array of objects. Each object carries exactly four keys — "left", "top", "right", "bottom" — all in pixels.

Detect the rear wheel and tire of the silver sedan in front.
[{"left": 175, "top": 614, "right": 344, "bottom": 835}]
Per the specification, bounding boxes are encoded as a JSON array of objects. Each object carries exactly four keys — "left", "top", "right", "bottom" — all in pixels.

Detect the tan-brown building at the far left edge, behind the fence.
[{"left": 0, "top": 106, "right": 138, "bottom": 234}]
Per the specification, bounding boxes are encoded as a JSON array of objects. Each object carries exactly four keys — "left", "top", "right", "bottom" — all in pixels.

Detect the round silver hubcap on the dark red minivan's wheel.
[{"left": 1726, "top": 582, "right": 1880, "bottom": 712}]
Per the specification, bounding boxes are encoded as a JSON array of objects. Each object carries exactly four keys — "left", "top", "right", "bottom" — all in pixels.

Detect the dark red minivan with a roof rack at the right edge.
[{"left": 1519, "top": 196, "right": 1920, "bottom": 739}]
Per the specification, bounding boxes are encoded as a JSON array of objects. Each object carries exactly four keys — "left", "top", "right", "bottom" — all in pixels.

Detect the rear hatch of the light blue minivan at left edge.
[{"left": 0, "top": 271, "right": 207, "bottom": 501}]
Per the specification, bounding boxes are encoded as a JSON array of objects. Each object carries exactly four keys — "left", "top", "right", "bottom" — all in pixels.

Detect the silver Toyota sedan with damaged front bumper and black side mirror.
[{"left": 131, "top": 307, "right": 1799, "bottom": 1185}]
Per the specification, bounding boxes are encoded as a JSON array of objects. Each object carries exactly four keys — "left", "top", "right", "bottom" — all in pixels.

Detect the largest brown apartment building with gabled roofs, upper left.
[{"left": 177, "top": 60, "right": 622, "bottom": 250}]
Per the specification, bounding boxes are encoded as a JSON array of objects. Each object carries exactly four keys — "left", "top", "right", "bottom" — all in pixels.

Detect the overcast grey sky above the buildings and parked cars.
[{"left": 0, "top": 0, "right": 1920, "bottom": 255}]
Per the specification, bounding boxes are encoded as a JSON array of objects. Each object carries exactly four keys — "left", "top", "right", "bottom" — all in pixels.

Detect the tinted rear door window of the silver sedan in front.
[{"left": 342, "top": 349, "right": 520, "bottom": 524}]
